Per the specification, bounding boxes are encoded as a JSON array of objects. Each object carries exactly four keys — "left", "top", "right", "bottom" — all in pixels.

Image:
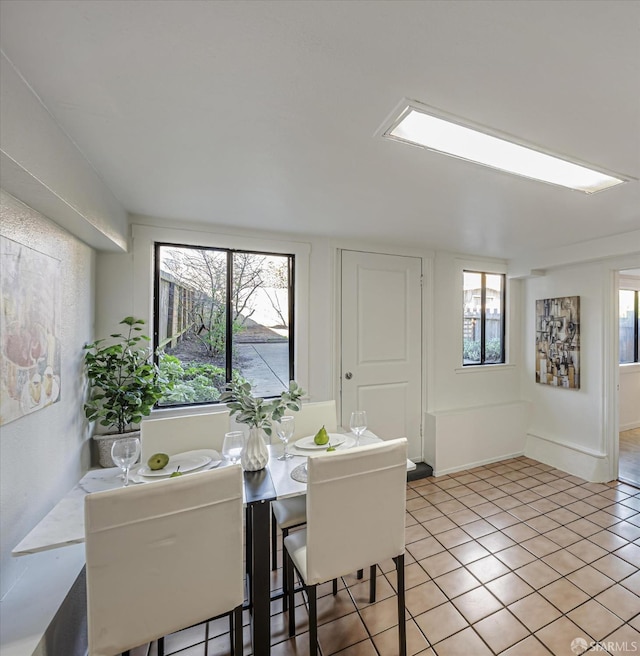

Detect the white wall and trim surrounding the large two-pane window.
[{"left": 96, "top": 217, "right": 334, "bottom": 402}]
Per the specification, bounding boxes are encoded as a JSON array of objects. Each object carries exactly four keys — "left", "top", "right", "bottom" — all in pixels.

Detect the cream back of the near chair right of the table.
[{"left": 307, "top": 438, "right": 407, "bottom": 584}]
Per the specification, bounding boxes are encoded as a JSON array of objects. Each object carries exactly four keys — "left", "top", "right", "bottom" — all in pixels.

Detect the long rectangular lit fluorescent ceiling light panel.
[{"left": 382, "top": 102, "right": 627, "bottom": 194}]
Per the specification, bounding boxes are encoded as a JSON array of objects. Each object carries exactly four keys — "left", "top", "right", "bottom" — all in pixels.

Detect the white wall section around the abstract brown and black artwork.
[{"left": 522, "top": 262, "right": 632, "bottom": 481}]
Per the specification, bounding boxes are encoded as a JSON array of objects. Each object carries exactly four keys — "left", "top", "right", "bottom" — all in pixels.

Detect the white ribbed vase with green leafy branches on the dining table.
[{"left": 220, "top": 380, "right": 305, "bottom": 471}]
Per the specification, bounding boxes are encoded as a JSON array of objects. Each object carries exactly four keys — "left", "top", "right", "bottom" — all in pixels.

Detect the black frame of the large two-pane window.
[{"left": 151, "top": 239, "right": 296, "bottom": 409}]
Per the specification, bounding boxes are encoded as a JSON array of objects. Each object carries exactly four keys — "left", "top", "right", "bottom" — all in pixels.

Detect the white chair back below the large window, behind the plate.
[{"left": 140, "top": 411, "right": 229, "bottom": 463}]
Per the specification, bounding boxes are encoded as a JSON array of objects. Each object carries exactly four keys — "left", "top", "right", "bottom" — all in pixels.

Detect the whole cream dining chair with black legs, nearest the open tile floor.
[{"left": 283, "top": 438, "right": 407, "bottom": 656}]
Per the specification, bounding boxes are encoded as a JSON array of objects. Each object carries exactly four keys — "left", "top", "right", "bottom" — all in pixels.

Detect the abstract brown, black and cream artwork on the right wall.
[{"left": 536, "top": 296, "right": 580, "bottom": 389}]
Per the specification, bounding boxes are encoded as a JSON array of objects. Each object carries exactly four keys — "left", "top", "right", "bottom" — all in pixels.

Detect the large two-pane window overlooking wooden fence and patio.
[{"left": 154, "top": 243, "right": 295, "bottom": 406}]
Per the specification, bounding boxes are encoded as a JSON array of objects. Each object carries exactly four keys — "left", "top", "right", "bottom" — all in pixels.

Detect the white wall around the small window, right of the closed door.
[{"left": 424, "top": 253, "right": 528, "bottom": 475}]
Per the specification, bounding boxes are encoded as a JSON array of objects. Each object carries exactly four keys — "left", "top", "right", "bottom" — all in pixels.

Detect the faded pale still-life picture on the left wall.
[{"left": 0, "top": 236, "right": 61, "bottom": 426}]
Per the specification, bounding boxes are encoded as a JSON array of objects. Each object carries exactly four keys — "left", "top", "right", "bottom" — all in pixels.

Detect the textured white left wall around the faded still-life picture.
[{"left": 0, "top": 191, "right": 95, "bottom": 597}]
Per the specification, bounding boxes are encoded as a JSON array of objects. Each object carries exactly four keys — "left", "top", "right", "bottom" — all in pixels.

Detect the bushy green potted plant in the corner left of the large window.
[{"left": 84, "top": 317, "right": 171, "bottom": 467}]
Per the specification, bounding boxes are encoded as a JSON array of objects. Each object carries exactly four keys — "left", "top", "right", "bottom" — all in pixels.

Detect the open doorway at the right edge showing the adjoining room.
[{"left": 618, "top": 269, "right": 640, "bottom": 487}]
